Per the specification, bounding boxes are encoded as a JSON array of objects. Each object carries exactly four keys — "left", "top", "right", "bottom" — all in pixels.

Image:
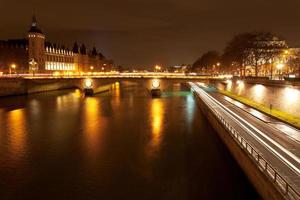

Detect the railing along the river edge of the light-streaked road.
[{"left": 193, "top": 86, "right": 300, "bottom": 200}]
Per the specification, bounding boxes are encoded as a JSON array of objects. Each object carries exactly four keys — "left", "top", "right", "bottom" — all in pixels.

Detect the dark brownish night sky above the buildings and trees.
[{"left": 0, "top": 0, "right": 300, "bottom": 68}]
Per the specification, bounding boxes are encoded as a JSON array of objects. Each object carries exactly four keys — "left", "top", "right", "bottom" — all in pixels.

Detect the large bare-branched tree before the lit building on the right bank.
[{"left": 222, "top": 32, "right": 287, "bottom": 76}]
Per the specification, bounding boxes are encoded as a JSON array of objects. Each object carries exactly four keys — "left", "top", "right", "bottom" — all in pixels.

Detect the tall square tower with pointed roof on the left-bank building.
[{"left": 28, "top": 16, "right": 45, "bottom": 71}]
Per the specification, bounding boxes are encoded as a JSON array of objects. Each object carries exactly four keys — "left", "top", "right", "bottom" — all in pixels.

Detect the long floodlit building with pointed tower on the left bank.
[{"left": 0, "top": 16, "right": 113, "bottom": 73}]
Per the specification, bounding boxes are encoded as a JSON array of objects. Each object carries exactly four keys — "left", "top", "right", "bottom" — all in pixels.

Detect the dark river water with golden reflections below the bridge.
[{"left": 0, "top": 81, "right": 259, "bottom": 200}]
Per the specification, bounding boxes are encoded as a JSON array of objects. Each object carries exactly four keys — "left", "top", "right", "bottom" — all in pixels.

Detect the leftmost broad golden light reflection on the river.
[{"left": 7, "top": 109, "right": 27, "bottom": 158}]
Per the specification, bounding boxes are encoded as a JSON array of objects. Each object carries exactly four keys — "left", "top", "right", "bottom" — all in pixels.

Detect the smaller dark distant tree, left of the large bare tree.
[{"left": 192, "top": 51, "right": 220, "bottom": 71}]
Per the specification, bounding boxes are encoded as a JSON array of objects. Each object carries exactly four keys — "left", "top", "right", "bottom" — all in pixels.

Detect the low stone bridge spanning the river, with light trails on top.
[{"left": 0, "top": 77, "right": 210, "bottom": 96}]
